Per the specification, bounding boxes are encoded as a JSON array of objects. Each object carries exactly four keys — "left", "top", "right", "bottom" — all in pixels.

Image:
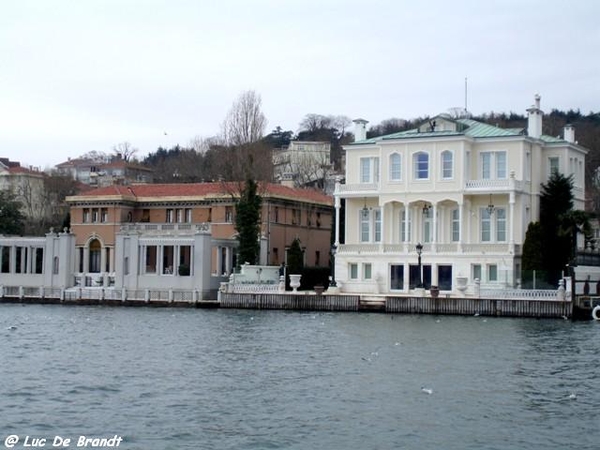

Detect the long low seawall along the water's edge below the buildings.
[{"left": 0, "top": 292, "right": 573, "bottom": 318}]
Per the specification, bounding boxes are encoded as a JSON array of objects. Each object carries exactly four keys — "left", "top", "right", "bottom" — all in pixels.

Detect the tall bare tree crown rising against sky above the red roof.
[{"left": 222, "top": 91, "right": 267, "bottom": 147}]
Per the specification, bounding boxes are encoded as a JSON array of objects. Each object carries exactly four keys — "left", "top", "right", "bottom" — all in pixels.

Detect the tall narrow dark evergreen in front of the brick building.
[{"left": 235, "top": 178, "right": 262, "bottom": 264}]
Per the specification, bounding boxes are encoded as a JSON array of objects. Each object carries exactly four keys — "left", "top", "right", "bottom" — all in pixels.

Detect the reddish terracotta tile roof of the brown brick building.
[{"left": 67, "top": 183, "right": 333, "bottom": 206}]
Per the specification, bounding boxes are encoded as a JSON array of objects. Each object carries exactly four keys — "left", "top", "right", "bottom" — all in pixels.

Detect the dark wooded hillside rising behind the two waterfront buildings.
[{"left": 143, "top": 109, "right": 600, "bottom": 213}]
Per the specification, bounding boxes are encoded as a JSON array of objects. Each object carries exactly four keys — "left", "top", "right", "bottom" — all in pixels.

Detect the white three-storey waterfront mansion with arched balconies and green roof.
[{"left": 334, "top": 95, "right": 587, "bottom": 295}]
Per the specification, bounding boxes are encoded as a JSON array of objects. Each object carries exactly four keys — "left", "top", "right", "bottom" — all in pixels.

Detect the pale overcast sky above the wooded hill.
[{"left": 0, "top": 0, "right": 600, "bottom": 168}]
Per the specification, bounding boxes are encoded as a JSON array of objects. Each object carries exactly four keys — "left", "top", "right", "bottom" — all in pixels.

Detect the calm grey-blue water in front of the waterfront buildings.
[{"left": 0, "top": 305, "right": 600, "bottom": 450}]
